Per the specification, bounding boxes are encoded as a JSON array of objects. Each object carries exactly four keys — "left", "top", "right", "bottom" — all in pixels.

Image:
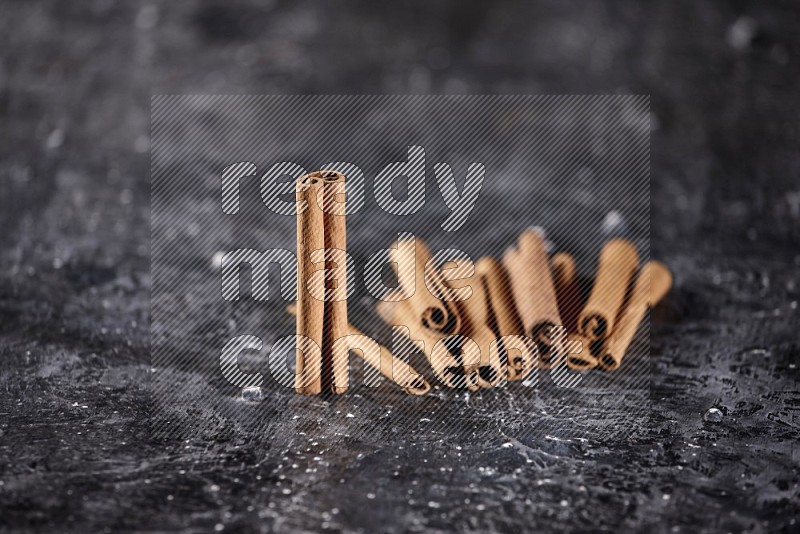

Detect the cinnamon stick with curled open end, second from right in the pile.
[{"left": 578, "top": 239, "right": 639, "bottom": 341}]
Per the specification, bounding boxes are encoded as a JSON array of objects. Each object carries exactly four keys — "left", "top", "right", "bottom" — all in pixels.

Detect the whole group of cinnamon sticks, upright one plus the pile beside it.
[{"left": 290, "top": 171, "right": 672, "bottom": 395}]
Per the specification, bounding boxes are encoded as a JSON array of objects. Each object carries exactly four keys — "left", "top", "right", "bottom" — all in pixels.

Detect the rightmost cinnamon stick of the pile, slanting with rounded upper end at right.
[{"left": 600, "top": 261, "right": 672, "bottom": 371}]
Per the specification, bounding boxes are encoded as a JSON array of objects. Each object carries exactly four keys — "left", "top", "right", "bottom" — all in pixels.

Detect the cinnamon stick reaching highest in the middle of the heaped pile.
[{"left": 503, "top": 228, "right": 566, "bottom": 368}]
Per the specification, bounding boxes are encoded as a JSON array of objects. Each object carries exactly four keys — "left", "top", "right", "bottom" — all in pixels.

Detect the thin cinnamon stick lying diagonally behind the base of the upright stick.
[{"left": 286, "top": 304, "right": 431, "bottom": 395}]
